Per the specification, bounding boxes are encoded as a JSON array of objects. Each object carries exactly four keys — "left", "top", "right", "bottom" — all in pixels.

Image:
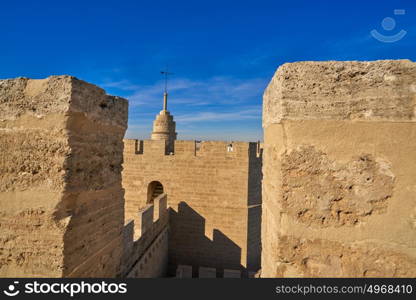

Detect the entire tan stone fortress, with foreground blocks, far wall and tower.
[{"left": 0, "top": 60, "right": 416, "bottom": 278}]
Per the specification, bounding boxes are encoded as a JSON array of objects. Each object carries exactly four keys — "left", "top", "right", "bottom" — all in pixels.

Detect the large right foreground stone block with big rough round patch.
[{"left": 261, "top": 60, "right": 416, "bottom": 277}]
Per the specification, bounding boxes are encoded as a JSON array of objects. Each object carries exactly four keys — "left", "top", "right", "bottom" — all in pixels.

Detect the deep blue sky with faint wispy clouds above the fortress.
[{"left": 0, "top": 0, "right": 416, "bottom": 141}]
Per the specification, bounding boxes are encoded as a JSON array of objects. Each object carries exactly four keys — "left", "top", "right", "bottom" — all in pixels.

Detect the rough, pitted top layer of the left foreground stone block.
[{"left": 0, "top": 75, "right": 128, "bottom": 129}]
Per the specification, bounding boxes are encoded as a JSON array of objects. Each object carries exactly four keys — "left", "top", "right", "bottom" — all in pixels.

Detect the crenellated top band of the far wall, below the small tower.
[{"left": 124, "top": 139, "right": 262, "bottom": 157}]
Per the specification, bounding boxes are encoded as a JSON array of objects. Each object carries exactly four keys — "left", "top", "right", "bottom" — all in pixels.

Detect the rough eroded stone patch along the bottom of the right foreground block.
[{"left": 276, "top": 236, "right": 416, "bottom": 277}]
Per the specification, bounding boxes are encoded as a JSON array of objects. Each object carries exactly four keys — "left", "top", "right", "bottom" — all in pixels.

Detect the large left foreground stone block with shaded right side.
[{"left": 0, "top": 76, "right": 127, "bottom": 277}]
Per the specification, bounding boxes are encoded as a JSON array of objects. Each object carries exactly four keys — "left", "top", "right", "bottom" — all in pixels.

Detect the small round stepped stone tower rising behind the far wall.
[{"left": 151, "top": 91, "right": 177, "bottom": 153}]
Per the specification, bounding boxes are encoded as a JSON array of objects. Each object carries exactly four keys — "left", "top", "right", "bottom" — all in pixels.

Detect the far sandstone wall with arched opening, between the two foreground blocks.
[{"left": 123, "top": 140, "right": 261, "bottom": 274}]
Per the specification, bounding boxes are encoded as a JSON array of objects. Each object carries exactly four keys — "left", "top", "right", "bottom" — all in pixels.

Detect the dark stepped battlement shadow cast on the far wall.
[{"left": 169, "top": 202, "right": 247, "bottom": 278}]
